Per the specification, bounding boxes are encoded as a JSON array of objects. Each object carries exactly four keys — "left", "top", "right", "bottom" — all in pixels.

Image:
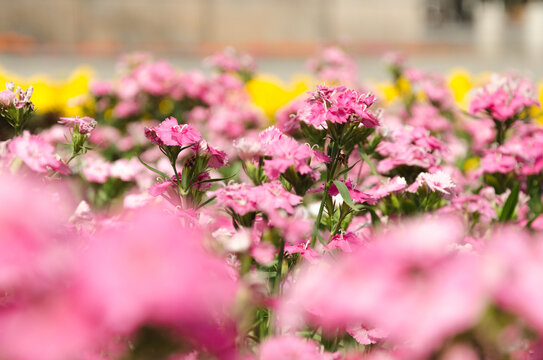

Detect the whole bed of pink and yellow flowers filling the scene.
[{"left": 0, "top": 48, "right": 543, "bottom": 360}]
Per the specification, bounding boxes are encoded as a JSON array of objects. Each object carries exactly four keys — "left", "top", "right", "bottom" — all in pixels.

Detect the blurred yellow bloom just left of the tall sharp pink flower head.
[{"left": 246, "top": 75, "right": 311, "bottom": 122}]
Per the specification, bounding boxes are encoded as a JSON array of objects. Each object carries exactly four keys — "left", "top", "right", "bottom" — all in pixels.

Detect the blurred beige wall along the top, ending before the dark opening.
[{"left": 0, "top": 0, "right": 425, "bottom": 45}]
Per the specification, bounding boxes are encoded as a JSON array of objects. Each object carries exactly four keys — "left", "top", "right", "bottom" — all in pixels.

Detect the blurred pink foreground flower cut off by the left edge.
[{"left": 0, "top": 174, "right": 75, "bottom": 292}]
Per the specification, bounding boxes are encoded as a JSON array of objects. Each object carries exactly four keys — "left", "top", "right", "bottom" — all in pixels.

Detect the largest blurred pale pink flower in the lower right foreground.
[{"left": 278, "top": 218, "right": 485, "bottom": 358}]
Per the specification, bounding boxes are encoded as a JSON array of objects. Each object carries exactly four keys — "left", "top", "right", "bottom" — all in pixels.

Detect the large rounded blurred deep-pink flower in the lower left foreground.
[{"left": 76, "top": 208, "right": 237, "bottom": 336}]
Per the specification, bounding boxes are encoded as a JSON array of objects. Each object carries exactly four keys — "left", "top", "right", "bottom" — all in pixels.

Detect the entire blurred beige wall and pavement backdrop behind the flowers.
[{"left": 0, "top": 0, "right": 543, "bottom": 78}]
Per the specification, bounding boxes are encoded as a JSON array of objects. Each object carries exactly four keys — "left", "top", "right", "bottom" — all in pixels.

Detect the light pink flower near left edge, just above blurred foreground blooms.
[{"left": 8, "top": 131, "right": 70, "bottom": 175}]
